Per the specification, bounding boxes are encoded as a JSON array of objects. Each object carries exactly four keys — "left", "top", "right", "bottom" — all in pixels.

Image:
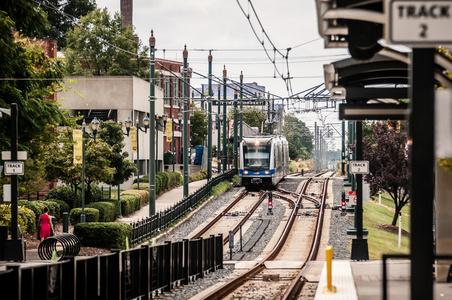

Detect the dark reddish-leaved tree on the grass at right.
[{"left": 363, "top": 121, "right": 410, "bottom": 225}]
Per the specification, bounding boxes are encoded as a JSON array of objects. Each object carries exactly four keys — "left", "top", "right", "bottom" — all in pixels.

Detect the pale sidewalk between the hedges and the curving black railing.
[{"left": 117, "top": 179, "right": 207, "bottom": 223}]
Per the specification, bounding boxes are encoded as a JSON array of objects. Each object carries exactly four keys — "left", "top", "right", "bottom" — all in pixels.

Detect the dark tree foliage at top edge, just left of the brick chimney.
[{"left": 35, "top": 0, "right": 96, "bottom": 49}]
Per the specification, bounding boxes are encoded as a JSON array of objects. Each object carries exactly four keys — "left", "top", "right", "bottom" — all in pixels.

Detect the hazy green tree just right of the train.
[{"left": 283, "top": 114, "right": 314, "bottom": 160}]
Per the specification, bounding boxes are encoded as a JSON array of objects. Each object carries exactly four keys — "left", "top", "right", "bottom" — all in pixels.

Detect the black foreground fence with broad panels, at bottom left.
[{"left": 0, "top": 235, "right": 223, "bottom": 300}]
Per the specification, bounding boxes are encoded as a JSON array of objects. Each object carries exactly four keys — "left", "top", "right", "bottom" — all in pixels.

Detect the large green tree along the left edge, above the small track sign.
[{"left": 0, "top": 0, "right": 66, "bottom": 192}]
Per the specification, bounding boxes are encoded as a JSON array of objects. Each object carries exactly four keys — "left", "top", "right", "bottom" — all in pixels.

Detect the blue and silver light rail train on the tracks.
[{"left": 239, "top": 135, "right": 289, "bottom": 187}]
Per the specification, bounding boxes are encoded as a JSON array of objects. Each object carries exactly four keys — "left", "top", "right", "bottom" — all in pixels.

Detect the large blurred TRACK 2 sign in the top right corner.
[{"left": 386, "top": 0, "right": 452, "bottom": 47}]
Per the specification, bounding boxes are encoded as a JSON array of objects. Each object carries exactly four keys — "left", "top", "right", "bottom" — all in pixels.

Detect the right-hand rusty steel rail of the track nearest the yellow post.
[{"left": 281, "top": 173, "right": 334, "bottom": 300}]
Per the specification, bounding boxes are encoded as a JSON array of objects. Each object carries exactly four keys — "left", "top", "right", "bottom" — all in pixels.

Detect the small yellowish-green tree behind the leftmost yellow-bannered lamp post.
[{"left": 44, "top": 128, "right": 115, "bottom": 207}]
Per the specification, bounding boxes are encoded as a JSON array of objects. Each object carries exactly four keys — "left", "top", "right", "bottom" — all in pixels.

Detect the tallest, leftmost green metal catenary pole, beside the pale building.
[{"left": 149, "top": 30, "right": 155, "bottom": 217}]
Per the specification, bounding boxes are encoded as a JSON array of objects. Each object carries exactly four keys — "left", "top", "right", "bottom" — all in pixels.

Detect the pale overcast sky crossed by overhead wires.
[{"left": 96, "top": 0, "right": 348, "bottom": 146}]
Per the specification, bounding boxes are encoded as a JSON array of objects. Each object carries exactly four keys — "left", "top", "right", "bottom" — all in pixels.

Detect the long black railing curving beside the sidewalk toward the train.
[{"left": 130, "top": 169, "right": 237, "bottom": 246}]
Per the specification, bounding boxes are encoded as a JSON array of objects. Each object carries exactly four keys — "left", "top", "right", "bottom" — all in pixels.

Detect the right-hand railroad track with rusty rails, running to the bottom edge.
[{"left": 202, "top": 171, "right": 334, "bottom": 299}]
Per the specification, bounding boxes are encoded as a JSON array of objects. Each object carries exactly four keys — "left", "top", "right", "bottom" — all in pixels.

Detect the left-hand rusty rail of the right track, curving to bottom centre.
[{"left": 202, "top": 178, "right": 312, "bottom": 299}]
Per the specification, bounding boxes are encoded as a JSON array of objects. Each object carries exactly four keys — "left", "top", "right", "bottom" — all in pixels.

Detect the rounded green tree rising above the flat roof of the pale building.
[{"left": 63, "top": 9, "right": 149, "bottom": 78}]
